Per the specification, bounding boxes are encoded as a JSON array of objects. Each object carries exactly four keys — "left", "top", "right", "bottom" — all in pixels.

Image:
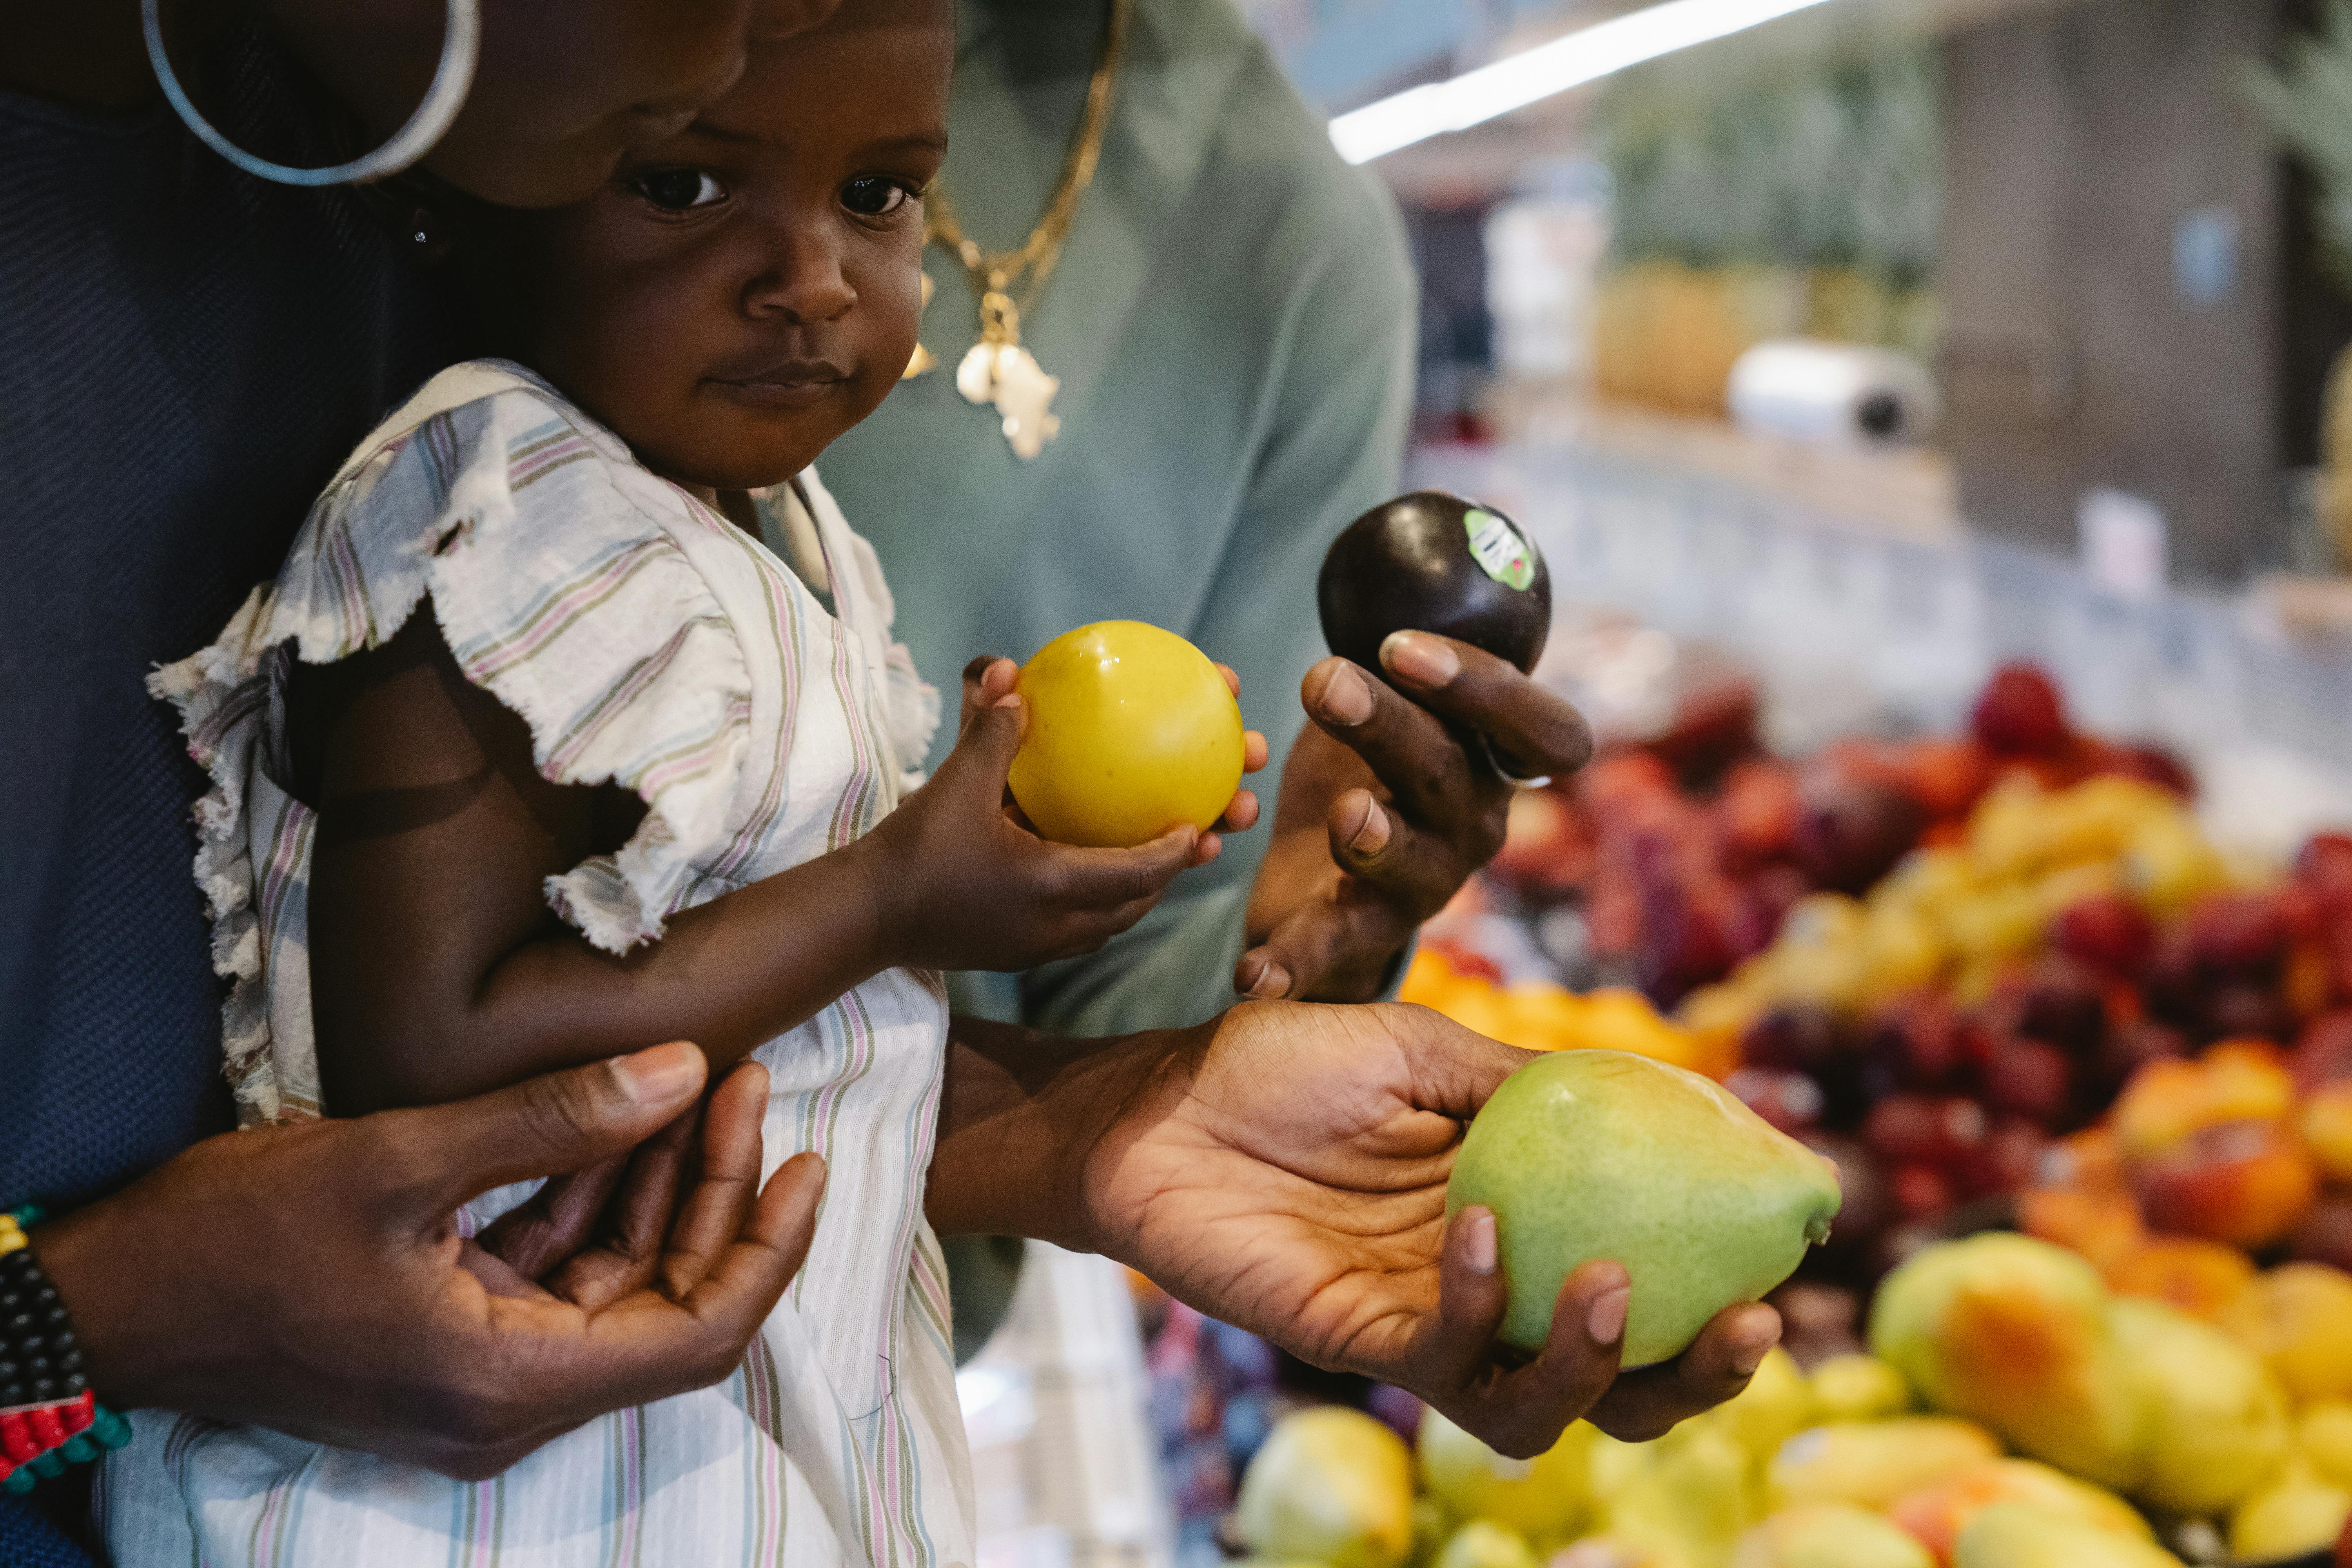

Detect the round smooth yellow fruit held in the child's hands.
[{"left": 1011, "top": 621, "right": 1244, "bottom": 849}]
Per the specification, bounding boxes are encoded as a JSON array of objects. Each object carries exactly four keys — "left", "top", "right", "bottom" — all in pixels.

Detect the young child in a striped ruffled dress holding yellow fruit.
[{"left": 99, "top": 0, "right": 1263, "bottom": 1568}]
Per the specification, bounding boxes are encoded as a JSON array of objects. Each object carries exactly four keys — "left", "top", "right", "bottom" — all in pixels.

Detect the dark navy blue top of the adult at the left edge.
[{"left": 0, "top": 42, "right": 452, "bottom": 1203}]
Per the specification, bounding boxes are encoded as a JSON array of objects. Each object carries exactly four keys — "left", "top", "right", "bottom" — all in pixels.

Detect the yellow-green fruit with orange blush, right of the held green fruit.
[{"left": 1870, "top": 1232, "right": 2147, "bottom": 1493}]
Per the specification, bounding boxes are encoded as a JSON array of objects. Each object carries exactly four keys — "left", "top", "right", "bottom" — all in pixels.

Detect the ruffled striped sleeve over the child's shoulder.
[{"left": 222, "top": 365, "right": 753, "bottom": 952}]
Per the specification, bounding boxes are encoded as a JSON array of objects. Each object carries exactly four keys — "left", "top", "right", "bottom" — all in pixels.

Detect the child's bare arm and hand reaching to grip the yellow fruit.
[{"left": 287, "top": 606, "right": 1254, "bottom": 1114}]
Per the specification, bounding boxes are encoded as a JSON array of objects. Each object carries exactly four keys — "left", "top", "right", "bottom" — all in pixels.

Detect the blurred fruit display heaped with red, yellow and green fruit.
[{"left": 1155, "top": 444, "right": 2352, "bottom": 1568}]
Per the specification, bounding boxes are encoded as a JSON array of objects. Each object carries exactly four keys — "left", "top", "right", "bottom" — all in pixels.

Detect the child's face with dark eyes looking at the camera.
[{"left": 522, "top": 0, "right": 955, "bottom": 489}]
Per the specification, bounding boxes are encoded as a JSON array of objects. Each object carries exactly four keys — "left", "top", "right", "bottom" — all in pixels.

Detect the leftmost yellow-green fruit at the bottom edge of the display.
[{"left": 1232, "top": 1406, "right": 1414, "bottom": 1568}]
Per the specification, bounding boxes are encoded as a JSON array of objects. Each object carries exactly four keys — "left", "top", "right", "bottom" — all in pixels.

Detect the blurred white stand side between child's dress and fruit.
[{"left": 955, "top": 1241, "right": 1174, "bottom": 1568}]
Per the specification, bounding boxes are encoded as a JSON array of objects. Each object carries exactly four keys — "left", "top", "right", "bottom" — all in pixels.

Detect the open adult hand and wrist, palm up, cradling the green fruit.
[{"left": 924, "top": 1004, "right": 1780, "bottom": 1455}]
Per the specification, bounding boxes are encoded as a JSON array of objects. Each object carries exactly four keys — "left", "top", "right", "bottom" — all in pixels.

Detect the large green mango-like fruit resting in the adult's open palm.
[{"left": 1446, "top": 1051, "right": 1839, "bottom": 1366}]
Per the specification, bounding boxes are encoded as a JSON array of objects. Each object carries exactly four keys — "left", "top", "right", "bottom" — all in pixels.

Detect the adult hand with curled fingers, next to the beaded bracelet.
[{"left": 33, "top": 1044, "right": 823, "bottom": 1479}]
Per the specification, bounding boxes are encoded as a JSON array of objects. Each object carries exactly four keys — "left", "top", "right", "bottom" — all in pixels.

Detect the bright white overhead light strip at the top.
[{"left": 1331, "top": 0, "right": 1823, "bottom": 162}]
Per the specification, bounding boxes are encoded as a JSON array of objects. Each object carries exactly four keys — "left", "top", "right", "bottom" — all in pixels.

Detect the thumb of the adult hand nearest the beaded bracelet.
[{"left": 395, "top": 1042, "right": 710, "bottom": 1213}]
